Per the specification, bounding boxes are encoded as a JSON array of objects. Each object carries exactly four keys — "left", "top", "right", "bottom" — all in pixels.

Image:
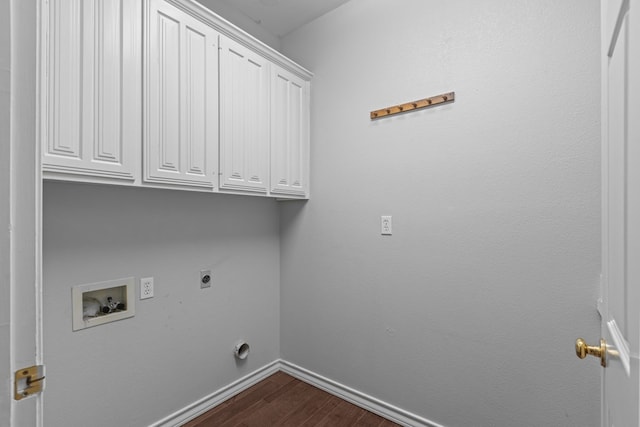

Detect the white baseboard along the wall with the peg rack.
[{"left": 280, "top": 360, "right": 444, "bottom": 427}]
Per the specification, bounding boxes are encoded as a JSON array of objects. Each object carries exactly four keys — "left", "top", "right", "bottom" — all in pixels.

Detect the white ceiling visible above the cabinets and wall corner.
[{"left": 212, "top": 0, "right": 349, "bottom": 37}]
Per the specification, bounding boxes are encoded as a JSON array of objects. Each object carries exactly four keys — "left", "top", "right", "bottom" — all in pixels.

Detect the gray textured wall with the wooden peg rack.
[{"left": 281, "top": 0, "right": 600, "bottom": 427}]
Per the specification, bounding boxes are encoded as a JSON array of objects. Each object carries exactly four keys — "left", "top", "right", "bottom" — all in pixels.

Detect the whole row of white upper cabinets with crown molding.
[{"left": 38, "top": 0, "right": 312, "bottom": 199}]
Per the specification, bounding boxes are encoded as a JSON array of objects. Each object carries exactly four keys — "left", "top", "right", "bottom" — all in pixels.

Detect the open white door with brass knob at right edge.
[{"left": 600, "top": 0, "right": 640, "bottom": 427}]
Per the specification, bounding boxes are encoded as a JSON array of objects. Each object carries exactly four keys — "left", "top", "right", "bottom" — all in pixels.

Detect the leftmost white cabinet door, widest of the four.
[{"left": 41, "top": 0, "right": 142, "bottom": 180}]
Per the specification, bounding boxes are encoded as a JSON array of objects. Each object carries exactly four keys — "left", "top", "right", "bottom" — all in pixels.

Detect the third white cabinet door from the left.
[{"left": 220, "top": 36, "right": 269, "bottom": 193}]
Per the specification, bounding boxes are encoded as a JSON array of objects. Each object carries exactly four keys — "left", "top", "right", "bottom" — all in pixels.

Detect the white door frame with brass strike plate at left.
[{"left": 6, "top": 0, "right": 43, "bottom": 427}]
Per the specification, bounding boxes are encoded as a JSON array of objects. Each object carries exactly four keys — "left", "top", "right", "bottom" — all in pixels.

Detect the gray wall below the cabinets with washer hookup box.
[{"left": 43, "top": 182, "right": 280, "bottom": 427}]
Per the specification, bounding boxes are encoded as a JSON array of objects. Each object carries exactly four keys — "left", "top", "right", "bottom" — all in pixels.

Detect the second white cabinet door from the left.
[{"left": 144, "top": 0, "right": 218, "bottom": 188}]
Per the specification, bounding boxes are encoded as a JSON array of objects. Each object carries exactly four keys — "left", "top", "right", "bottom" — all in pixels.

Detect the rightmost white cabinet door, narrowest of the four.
[{"left": 271, "top": 65, "right": 309, "bottom": 196}]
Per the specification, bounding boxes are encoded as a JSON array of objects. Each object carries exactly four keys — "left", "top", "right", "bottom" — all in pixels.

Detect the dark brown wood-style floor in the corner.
[{"left": 183, "top": 372, "right": 398, "bottom": 427}]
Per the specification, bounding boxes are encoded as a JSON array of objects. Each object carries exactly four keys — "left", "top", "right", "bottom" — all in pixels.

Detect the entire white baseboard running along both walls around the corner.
[{"left": 149, "top": 360, "right": 444, "bottom": 427}]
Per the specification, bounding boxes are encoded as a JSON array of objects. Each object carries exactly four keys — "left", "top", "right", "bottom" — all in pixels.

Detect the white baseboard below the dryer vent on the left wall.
[{"left": 149, "top": 360, "right": 280, "bottom": 427}]
